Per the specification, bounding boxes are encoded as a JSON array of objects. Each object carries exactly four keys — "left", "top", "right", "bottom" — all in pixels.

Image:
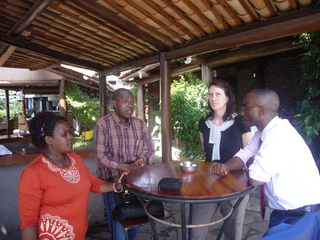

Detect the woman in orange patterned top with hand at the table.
[{"left": 18, "top": 112, "right": 122, "bottom": 240}]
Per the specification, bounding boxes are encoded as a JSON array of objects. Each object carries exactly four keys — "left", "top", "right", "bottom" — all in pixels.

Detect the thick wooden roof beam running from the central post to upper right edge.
[{"left": 166, "top": 9, "right": 320, "bottom": 60}]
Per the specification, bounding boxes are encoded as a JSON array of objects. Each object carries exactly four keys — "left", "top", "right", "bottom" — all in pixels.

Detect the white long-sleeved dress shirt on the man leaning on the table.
[{"left": 235, "top": 117, "right": 320, "bottom": 210}]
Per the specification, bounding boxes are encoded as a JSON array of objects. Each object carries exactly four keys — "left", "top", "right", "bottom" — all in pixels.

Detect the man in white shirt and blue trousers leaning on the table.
[{"left": 212, "top": 89, "right": 320, "bottom": 239}]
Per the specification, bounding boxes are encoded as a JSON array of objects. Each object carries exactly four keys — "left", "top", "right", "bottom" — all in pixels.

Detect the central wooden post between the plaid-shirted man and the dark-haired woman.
[{"left": 160, "top": 53, "right": 172, "bottom": 162}]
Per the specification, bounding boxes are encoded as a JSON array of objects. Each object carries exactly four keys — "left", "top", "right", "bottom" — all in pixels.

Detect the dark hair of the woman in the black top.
[{"left": 204, "top": 79, "right": 236, "bottom": 121}]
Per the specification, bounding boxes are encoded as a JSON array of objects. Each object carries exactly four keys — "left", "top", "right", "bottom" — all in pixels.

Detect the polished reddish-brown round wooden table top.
[{"left": 125, "top": 161, "right": 254, "bottom": 201}]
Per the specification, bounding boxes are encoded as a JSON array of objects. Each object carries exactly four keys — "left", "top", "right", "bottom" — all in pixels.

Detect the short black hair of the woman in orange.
[{"left": 29, "top": 111, "right": 68, "bottom": 149}]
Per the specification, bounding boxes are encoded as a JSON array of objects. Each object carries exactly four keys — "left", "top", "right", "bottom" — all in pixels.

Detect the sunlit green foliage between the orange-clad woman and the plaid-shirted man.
[{"left": 64, "top": 84, "right": 100, "bottom": 133}]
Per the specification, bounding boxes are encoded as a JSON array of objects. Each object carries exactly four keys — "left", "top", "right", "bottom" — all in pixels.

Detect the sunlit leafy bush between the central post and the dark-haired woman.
[{"left": 171, "top": 73, "right": 208, "bottom": 161}]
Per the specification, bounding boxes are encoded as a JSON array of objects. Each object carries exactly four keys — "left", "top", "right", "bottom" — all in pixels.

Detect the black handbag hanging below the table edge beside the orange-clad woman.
[{"left": 111, "top": 190, "right": 164, "bottom": 222}]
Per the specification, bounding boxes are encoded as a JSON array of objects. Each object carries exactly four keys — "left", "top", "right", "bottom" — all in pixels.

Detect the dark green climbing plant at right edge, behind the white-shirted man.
[{"left": 294, "top": 31, "right": 320, "bottom": 158}]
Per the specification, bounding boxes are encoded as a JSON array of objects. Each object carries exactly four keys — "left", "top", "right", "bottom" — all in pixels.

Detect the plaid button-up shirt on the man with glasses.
[{"left": 94, "top": 112, "right": 155, "bottom": 180}]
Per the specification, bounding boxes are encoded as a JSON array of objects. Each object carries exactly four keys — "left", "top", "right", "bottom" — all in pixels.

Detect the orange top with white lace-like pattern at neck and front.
[{"left": 18, "top": 152, "right": 103, "bottom": 240}]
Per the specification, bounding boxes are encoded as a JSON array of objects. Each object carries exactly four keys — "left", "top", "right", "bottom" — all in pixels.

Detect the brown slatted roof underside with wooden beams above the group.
[{"left": 0, "top": 0, "right": 320, "bottom": 86}]
